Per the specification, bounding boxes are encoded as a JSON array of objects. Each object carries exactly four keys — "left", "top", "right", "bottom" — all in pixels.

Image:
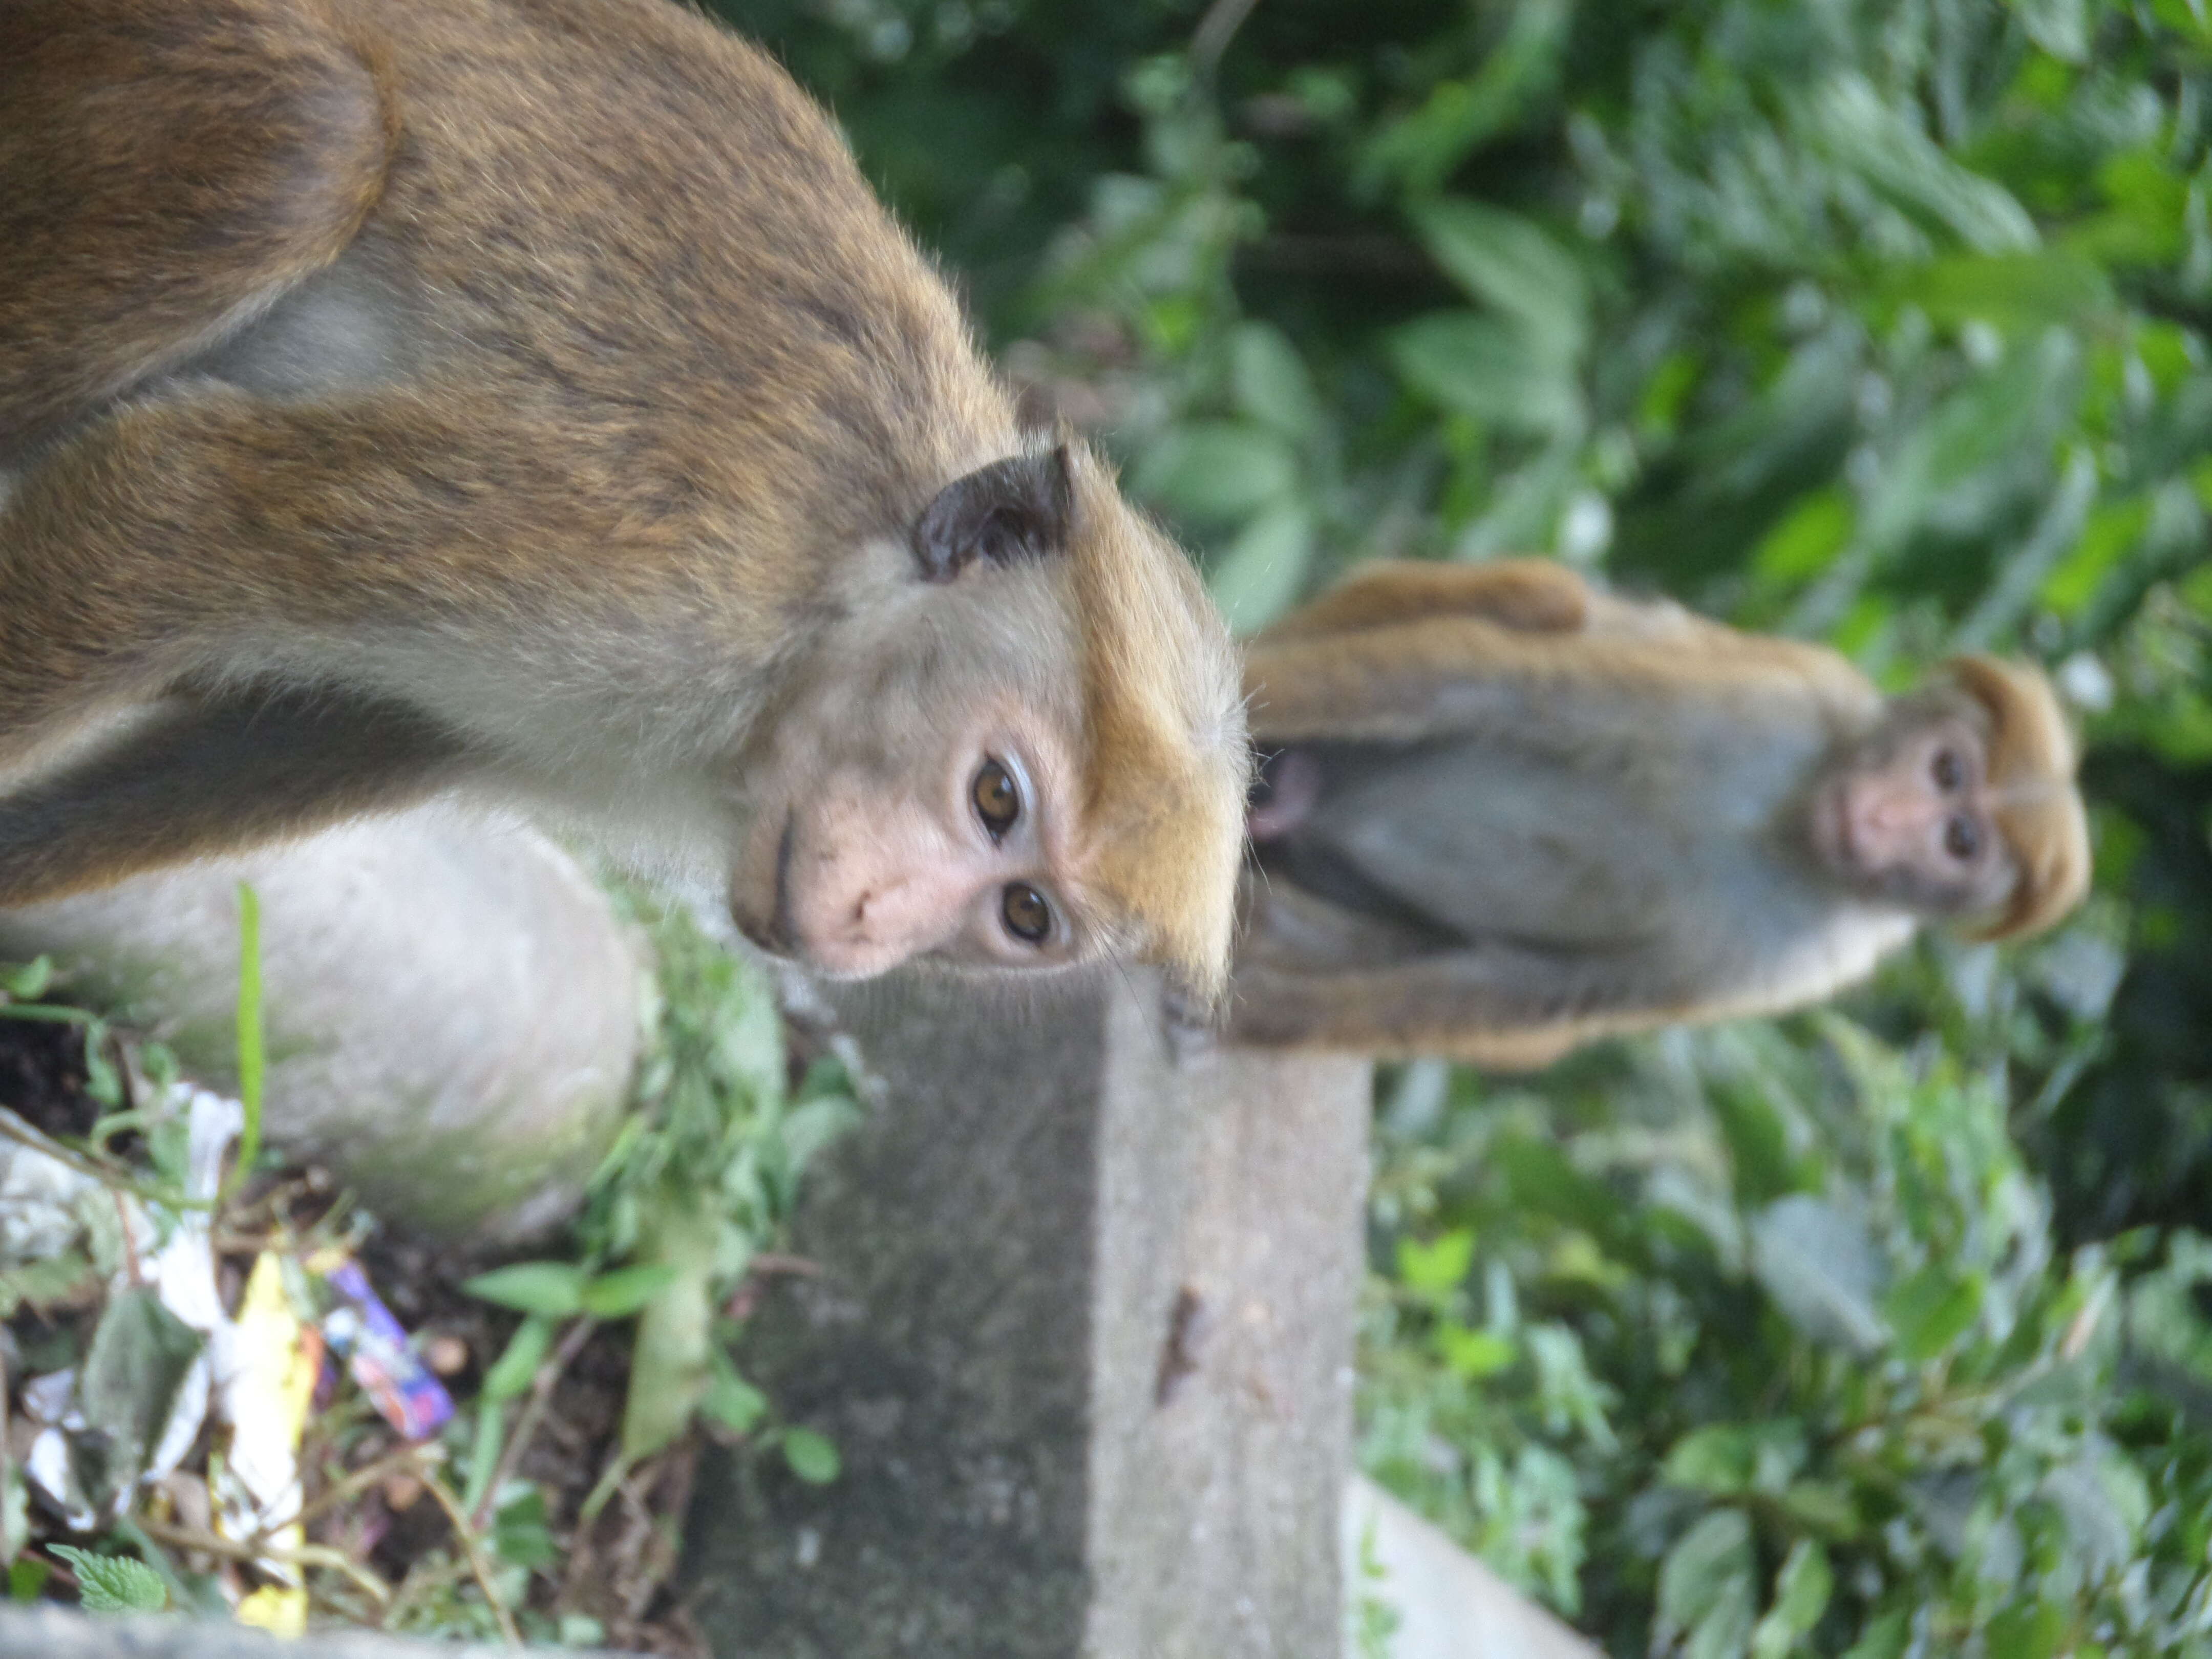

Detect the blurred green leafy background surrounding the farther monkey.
[{"left": 719, "top": 0, "right": 2212, "bottom": 1659}]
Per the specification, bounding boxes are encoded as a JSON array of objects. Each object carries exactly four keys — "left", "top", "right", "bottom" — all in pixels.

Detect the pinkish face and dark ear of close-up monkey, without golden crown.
[{"left": 730, "top": 451, "right": 1097, "bottom": 977}]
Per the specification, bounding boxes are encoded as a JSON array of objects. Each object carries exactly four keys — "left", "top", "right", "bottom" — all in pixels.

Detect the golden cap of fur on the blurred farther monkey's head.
[{"left": 1944, "top": 657, "right": 2090, "bottom": 940}]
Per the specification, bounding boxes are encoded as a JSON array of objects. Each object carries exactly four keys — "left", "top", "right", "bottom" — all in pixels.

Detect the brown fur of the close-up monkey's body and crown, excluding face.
[{"left": 0, "top": 0, "right": 1245, "bottom": 987}]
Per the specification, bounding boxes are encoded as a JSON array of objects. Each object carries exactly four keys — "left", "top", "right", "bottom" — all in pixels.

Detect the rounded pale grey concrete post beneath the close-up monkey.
[{"left": 0, "top": 807, "right": 646, "bottom": 1243}]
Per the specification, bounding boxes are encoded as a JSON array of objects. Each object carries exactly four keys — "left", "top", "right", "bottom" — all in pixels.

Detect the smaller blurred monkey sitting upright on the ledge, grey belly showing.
[{"left": 1232, "top": 560, "right": 2088, "bottom": 1069}]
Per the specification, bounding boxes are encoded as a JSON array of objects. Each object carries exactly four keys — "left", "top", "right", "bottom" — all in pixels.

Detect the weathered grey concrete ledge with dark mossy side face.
[{"left": 688, "top": 975, "right": 1367, "bottom": 1659}]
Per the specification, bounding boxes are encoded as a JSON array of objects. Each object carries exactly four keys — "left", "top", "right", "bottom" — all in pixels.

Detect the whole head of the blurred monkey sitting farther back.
[{"left": 1812, "top": 657, "right": 2090, "bottom": 938}]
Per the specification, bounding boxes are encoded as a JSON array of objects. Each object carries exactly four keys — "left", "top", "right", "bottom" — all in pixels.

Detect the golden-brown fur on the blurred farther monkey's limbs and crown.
[{"left": 1230, "top": 560, "right": 2090, "bottom": 1071}]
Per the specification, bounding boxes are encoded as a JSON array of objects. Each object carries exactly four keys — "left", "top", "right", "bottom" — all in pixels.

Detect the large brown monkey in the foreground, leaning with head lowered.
[{"left": 0, "top": 0, "right": 1247, "bottom": 993}]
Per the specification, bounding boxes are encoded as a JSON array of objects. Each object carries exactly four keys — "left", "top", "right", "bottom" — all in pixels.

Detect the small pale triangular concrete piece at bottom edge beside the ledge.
[{"left": 1343, "top": 1475, "right": 1604, "bottom": 1659}]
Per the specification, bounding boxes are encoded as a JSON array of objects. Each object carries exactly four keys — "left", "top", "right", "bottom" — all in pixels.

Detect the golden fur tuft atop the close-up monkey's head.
[{"left": 1069, "top": 444, "right": 1252, "bottom": 1007}]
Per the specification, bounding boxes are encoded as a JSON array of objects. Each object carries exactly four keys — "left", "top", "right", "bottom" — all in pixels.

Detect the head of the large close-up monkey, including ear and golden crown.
[{"left": 730, "top": 444, "right": 1250, "bottom": 1000}]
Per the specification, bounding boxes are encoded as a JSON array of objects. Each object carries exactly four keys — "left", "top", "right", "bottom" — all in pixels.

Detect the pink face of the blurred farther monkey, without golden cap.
[{"left": 1812, "top": 704, "right": 2017, "bottom": 916}]
